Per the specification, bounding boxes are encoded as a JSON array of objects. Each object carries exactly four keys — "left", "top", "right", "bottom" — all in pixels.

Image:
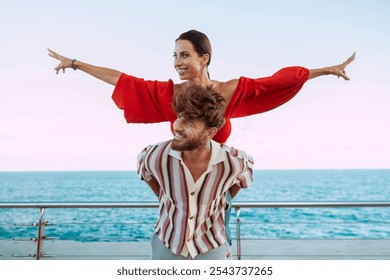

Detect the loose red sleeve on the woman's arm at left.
[{"left": 112, "top": 73, "right": 176, "bottom": 123}]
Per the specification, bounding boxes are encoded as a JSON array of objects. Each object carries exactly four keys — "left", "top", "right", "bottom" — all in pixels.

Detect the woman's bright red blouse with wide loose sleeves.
[{"left": 112, "top": 66, "right": 309, "bottom": 143}]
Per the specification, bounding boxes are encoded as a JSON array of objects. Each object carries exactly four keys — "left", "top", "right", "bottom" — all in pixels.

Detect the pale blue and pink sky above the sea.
[{"left": 0, "top": 0, "right": 390, "bottom": 171}]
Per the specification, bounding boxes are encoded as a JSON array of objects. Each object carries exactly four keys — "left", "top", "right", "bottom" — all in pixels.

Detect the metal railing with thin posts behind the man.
[{"left": 0, "top": 201, "right": 390, "bottom": 260}]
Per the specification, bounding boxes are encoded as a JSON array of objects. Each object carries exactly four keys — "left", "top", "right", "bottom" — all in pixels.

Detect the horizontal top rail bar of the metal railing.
[{"left": 0, "top": 201, "right": 390, "bottom": 208}]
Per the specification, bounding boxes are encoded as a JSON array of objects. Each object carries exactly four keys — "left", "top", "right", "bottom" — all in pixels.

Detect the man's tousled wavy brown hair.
[{"left": 172, "top": 85, "right": 225, "bottom": 129}]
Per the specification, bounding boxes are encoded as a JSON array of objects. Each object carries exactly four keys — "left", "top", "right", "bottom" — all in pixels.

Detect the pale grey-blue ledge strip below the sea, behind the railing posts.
[{"left": 0, "top": 239, "right": 390, "bottom": 260}]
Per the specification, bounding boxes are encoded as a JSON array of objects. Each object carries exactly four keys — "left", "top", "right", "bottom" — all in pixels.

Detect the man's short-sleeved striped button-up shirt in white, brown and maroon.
[{"left": 138, "top": 141, "right": 253, "bottom": 258}]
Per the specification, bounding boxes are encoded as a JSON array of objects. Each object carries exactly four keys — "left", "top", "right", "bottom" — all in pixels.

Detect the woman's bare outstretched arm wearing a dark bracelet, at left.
[{"left": 47, "top": 49, "right": 122, "bottom": 86}]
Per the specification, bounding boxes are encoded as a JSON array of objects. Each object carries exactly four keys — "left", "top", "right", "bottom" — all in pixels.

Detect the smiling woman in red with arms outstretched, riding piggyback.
[{"left": 49, "top": 30, "right": 355, "bottom": 246}]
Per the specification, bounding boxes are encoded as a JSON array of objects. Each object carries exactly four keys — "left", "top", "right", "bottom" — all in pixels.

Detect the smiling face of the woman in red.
[{"left": 173, "top": 40, "right": 208, "bottom": 80}]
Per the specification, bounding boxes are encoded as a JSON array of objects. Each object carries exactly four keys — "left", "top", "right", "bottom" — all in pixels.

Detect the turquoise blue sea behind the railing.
[{"left": 0, "top": 169, "right": 390, "bottom": 242}]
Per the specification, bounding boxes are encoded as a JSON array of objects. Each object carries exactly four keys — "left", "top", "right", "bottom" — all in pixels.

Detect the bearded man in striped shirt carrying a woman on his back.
[{"left": 138, "top": 86, "right": 253, "bottom": 260}]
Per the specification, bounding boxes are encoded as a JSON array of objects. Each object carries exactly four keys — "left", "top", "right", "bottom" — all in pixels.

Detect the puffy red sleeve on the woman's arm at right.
[{"left": 226, "top": 66, "right": 309, "bottom": 118}]
